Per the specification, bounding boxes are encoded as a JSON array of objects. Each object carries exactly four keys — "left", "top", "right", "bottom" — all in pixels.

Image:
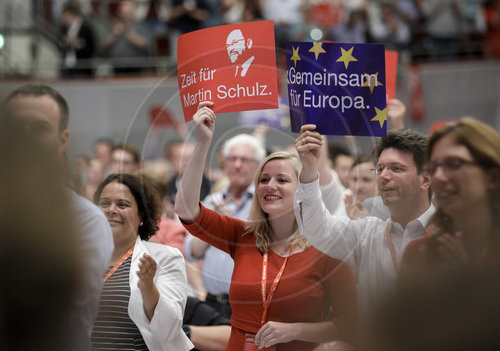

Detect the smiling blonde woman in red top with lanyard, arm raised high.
[{"left": 175, "top": 101, "right": 357, "bottom": 351}]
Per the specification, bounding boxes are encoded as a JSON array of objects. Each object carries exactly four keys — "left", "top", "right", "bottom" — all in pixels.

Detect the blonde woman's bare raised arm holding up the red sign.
[{"left": 175, "top": 101, "right": 215, "bottom": 224}]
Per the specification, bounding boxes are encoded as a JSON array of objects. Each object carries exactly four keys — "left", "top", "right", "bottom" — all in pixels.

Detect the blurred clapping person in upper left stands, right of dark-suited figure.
[{"left": 103, "top": 0, "right": 151, "bottom": 74}]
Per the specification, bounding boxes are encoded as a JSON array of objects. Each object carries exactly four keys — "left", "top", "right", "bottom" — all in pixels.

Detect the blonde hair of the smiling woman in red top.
[{"left": 245, "top": 151, "right": 311, "bottom": 253}]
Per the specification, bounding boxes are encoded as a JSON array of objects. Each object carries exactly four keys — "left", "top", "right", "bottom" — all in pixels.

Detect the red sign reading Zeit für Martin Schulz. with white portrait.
[{"left": 177, "top": 21, "right": 278, "bottom": 122}]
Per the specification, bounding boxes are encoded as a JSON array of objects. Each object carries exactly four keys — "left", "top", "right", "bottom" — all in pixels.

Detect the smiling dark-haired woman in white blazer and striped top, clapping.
[{"left": 92, "top": 174, "right": 193, "bottom": 351}]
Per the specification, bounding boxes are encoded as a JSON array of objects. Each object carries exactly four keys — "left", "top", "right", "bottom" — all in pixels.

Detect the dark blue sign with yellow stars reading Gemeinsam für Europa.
[{"left": 286, "top": 42, "right": 387, "bottom": 137}]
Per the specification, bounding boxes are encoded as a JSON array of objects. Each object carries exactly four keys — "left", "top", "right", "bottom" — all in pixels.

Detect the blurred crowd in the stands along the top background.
[{"left": 49, "top": 0, "right": 500, "bottom": 78}]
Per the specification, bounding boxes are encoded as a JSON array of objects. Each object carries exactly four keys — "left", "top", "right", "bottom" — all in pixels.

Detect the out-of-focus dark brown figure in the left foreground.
[{"left": 0, "top": 104, "right": 84, "bottom": 351}]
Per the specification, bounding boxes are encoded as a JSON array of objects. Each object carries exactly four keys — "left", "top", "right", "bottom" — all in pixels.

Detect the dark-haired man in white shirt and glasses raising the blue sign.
[{"left": 295, "top": 124, "right": 434, "bottom": 331}]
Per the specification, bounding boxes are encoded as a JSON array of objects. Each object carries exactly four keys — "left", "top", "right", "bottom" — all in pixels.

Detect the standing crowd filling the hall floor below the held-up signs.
[{"left": 0, "top": 83, "right": 500, "bottom": 351}]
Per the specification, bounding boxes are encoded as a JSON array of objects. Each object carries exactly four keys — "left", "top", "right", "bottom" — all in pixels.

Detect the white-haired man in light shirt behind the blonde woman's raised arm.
[{"left": 185, "top": 134, "right": 265, "bottom": 318}]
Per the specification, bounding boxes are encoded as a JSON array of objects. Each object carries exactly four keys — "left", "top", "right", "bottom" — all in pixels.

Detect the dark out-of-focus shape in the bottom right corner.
[{"left": 367, "top": 256, "right": 500, "bottom": 351}]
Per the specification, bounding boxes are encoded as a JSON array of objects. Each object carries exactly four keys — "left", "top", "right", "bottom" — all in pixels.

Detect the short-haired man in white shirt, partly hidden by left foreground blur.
[{"left": 6, "top": 83, "right": 113, "bottom": 350}]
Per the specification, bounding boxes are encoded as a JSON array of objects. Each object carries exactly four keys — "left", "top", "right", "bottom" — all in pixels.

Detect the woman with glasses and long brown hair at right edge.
[{"left": 403, "top": 117, "right": 500, "bottom": 274}]
